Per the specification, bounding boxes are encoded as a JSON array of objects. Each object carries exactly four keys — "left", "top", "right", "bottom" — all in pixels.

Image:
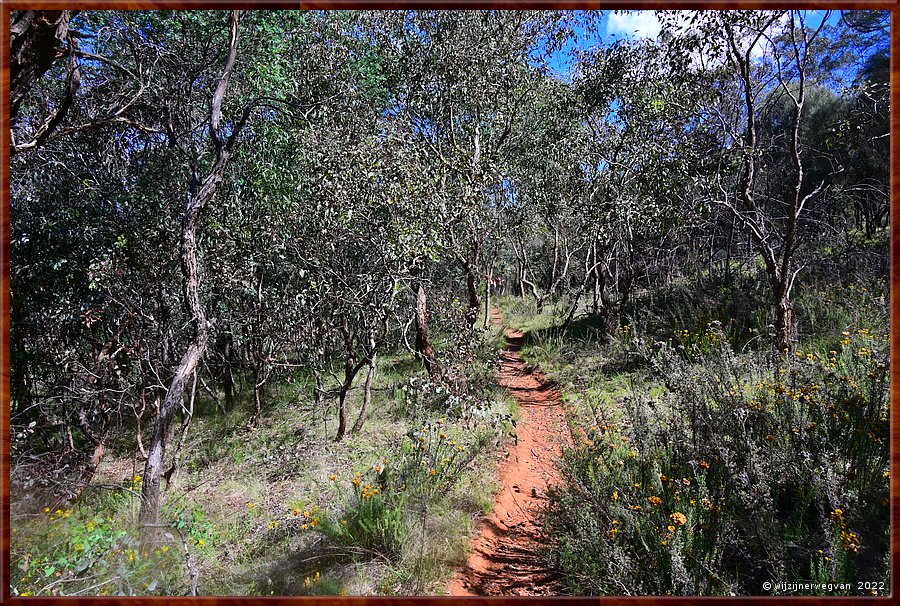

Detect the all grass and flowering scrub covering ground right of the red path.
[{"left": 509, "top": 264, "right": 890, "bottom": 595}]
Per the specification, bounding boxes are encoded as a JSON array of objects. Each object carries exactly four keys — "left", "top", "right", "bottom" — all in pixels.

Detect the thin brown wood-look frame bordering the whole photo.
[{"left": 0, "top": 0, "right": 900, "bottom": 606}]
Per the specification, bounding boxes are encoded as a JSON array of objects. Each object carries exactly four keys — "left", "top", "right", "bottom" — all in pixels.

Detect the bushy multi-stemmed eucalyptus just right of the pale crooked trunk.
[{"left": 219, "top": 13, "right": 442, "bottom": 439}]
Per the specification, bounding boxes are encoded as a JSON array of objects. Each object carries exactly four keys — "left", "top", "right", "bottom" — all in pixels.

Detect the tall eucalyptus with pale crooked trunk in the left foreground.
[{"left": 14, "top": 11, "right": 352, "bottom": 538}]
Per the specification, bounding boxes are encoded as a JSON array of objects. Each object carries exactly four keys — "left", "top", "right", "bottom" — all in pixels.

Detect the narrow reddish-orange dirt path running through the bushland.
[{"left": 447, "top": 309, "right": 568, "bottom": 596}]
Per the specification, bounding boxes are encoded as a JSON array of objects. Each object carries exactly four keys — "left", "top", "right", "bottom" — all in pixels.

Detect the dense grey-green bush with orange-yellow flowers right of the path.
[{"left": 547, "top": 329, "right": 889, "bottom": 595}]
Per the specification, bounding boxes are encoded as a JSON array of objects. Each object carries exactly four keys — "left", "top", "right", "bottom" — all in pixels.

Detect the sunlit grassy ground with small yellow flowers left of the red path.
[{"left": 11, "top": 320, "right": 518, "bottom": 596}]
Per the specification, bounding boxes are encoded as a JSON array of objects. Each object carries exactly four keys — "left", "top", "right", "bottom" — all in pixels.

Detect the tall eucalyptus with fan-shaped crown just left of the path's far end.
[{"left": 381, "top": 11, "right": 570, "bottom": 322}]
